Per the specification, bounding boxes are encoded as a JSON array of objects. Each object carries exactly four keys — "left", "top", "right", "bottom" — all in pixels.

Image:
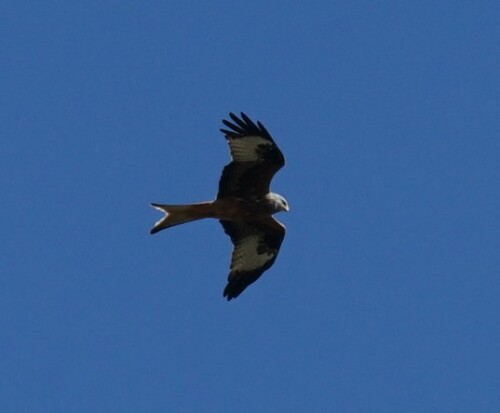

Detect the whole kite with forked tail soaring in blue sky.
[{"left": 151, "top": 113, "right": 288, "bottom": 301}]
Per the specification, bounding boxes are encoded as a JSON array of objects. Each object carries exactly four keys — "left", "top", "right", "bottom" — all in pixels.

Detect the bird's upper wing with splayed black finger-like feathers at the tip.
[{"left": 217, "top": 112, "right": 285, "bottom": 198}]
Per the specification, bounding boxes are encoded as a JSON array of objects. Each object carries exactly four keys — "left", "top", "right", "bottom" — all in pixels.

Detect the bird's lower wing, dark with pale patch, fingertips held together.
[{"left": 220, "top": 217, "right": 285, "bottom": 301}]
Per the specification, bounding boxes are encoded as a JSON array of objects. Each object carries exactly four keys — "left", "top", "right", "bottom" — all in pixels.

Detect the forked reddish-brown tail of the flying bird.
[{"left": 151, "top": 202, "right": 214, "bottom": 234}]
